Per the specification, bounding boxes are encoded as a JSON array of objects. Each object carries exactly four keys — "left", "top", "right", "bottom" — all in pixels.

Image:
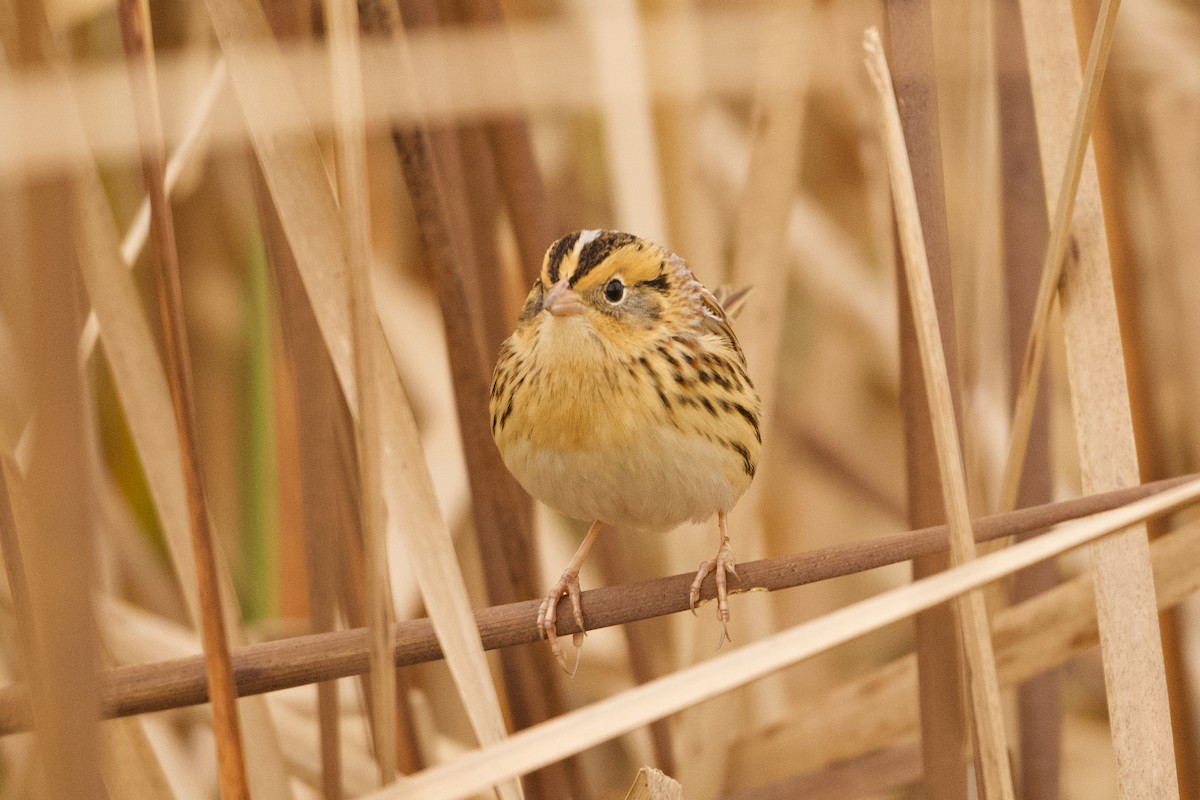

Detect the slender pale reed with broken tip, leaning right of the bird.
[{"left": 864, "top": 29, "right": 1013, "bottom": 798}]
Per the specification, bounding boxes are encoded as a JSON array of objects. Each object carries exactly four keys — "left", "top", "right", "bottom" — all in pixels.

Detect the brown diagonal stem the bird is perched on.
[{"left": 0, "top": 474, "right": 1185, "bottom": 735}]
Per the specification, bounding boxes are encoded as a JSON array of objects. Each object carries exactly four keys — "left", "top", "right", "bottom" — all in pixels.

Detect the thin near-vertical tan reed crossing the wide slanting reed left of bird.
[{"left": 325, "top": 0, "right": 396, "bottom": 786}]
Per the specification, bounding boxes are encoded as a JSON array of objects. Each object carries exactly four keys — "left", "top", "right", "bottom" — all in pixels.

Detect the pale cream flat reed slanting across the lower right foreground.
[{"left": 364, "top": 481, "right": 1200, "bottom": 800}]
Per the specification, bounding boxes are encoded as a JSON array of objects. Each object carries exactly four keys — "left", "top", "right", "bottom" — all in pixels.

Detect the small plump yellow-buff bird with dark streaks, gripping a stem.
[{"left": 490, "top": 230, "right": 762, "bottom": 672}]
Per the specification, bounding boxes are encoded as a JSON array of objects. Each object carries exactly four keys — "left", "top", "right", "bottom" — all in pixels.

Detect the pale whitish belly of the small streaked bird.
[{"left": 504, "top": 426, "right": 749, "bottom": 531}]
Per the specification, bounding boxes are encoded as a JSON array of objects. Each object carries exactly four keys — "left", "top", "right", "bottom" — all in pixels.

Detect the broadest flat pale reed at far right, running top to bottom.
[{"left": 1022, "top": 0, "right": 1178, "bottom": 798}]
